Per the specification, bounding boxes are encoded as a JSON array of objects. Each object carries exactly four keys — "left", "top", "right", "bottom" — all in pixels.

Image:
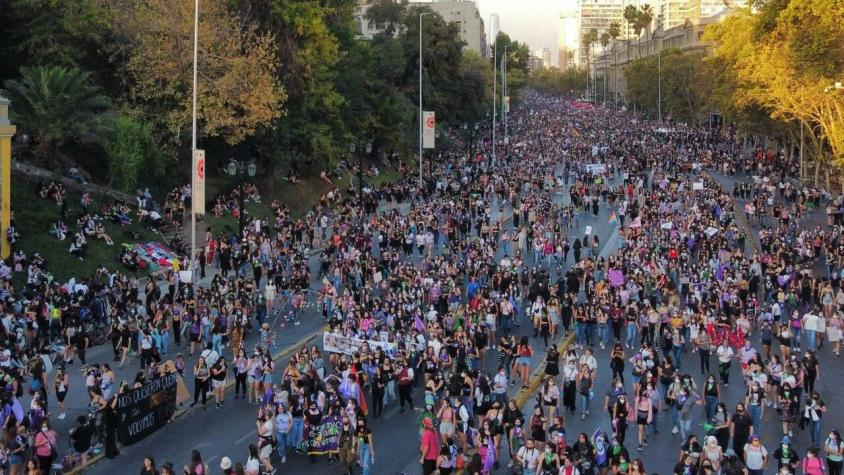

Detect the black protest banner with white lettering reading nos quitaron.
[{"left": 116, "top": 374, "right": 179, "bottom": 445}]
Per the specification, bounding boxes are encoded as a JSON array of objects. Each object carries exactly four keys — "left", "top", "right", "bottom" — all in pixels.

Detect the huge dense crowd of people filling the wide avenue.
[{"left": 0, "top": 93, "right": 844, "bottom": 475}]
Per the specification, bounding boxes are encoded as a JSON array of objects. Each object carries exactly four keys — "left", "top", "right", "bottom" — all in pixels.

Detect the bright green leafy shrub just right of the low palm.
[{"left": 105, "top": 116, "right": 165, "bottom": 193}]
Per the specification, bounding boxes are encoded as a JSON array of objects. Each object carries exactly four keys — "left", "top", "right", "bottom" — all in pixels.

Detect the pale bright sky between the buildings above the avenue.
[{"left": 475, "top": 0, "right": 576, "bottom": 65}]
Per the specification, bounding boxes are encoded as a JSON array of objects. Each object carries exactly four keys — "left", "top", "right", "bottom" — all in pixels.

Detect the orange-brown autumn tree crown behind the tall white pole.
[{"left": 115, "top": 0, "right": 285, "bottom": 146}]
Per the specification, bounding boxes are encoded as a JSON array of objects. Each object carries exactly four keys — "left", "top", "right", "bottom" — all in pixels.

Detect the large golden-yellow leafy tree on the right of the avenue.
[{"left": 705, "top": 0, "right": 844, "bottom": 177}]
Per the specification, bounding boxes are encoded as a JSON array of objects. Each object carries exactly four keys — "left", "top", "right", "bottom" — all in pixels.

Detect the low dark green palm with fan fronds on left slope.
[{"left": 5, "top": 66, "right": 113, "bottom": 160}]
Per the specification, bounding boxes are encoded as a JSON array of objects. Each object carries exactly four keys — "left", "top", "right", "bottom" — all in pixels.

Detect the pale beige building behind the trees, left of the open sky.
[{"left": 357, "top": 0, "right": 488, "bottom": 56}]
